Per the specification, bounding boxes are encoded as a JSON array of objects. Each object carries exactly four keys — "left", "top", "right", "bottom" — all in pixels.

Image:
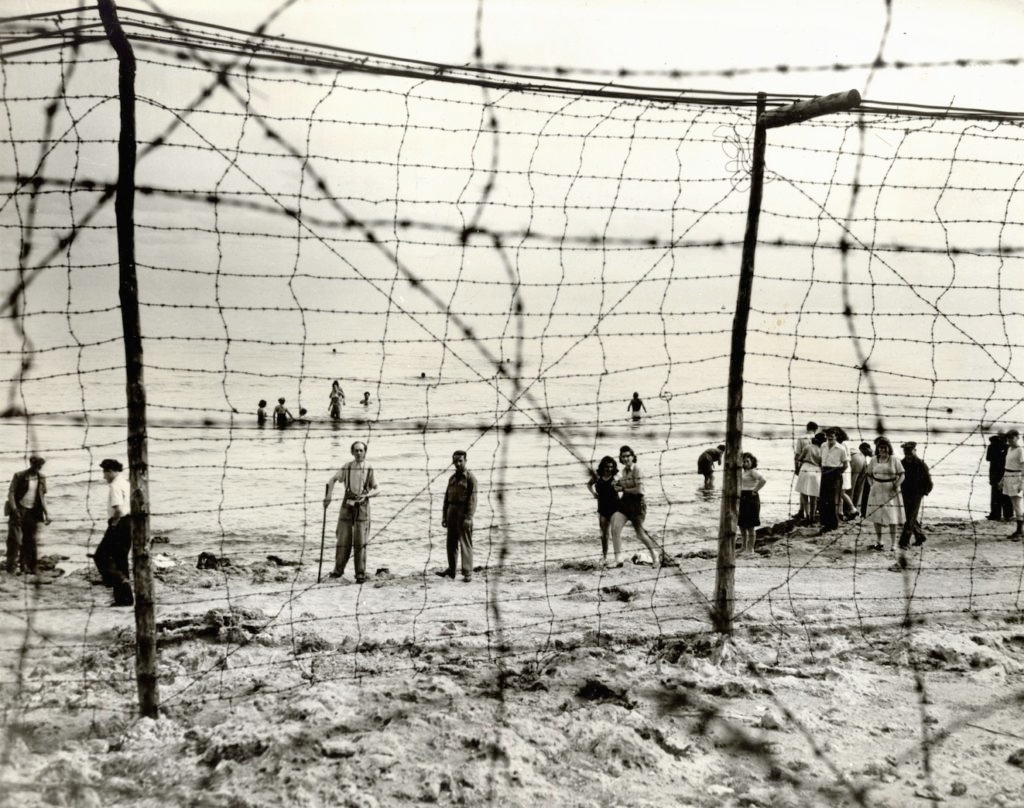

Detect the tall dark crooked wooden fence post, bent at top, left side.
[{"left": 97, "top": 0, "right": 160, "bottom": 718}]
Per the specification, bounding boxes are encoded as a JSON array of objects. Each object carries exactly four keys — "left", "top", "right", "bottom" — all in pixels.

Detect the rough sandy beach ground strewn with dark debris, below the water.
[{"left": 0, "top": 522, "right": 1024, "bottom": 808}]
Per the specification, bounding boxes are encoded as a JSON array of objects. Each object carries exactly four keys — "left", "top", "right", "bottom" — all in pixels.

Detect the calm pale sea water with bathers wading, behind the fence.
[{"left": 0, "top": 325, "right": 1007, "bottom": 573}]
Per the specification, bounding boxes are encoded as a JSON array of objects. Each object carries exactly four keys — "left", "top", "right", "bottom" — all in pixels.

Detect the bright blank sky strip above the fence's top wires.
[{"left": 6, "top": 0, "right": 1024, "bottom": 110}]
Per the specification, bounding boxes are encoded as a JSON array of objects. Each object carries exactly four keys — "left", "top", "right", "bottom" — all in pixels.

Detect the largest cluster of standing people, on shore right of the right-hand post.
[{"left": 794, "top": 421, "right": 933, "bottom": 553}]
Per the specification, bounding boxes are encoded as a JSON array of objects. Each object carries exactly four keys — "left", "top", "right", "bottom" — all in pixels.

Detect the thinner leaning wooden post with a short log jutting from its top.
[{"left": 712, "top": 90, "right": 860, "bottom": 634}]
